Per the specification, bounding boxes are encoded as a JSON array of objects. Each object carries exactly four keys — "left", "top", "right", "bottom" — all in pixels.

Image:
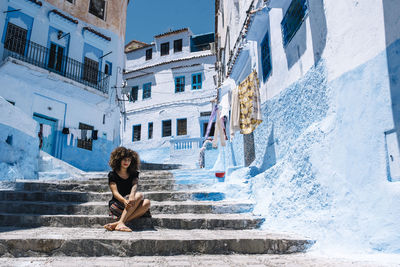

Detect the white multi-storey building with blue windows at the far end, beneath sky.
[{"left": 123, "top": 28, "right": 216, "bottom": 168}]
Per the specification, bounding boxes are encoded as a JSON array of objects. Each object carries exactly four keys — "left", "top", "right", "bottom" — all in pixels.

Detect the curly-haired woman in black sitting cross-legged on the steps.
[{"left": 104, "top": 147, "right": 150, "bottom": 232}]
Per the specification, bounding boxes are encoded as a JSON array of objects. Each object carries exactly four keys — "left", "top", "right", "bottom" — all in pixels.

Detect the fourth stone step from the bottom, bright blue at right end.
[{"left": 0, "top": 190, "right": 225, "bottom": 202}]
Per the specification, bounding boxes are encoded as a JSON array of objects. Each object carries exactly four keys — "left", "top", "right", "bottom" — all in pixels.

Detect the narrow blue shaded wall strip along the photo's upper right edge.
[{"left": 383, "top": 0, "right": 400, "bottom": 149}]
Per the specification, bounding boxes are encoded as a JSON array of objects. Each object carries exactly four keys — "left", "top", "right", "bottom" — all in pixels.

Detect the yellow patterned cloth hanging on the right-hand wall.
[{"left": 238, "top": 71, "right": 262, "bottom": 134}]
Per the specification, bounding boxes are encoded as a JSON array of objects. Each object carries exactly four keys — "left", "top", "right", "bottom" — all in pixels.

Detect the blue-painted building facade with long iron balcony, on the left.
[{"left": 0, "top": 0, "right": 128, "bottom": 171}]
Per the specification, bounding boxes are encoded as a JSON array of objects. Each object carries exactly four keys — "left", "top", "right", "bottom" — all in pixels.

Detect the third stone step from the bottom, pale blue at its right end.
[{"left": 0, "top": 201, "right": 253, "bottom": 215}]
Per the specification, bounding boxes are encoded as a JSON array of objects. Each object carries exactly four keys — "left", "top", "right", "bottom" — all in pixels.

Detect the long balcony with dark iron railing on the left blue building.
[{"left": 3, "top": 35, "right": 110, "bottom": 94}]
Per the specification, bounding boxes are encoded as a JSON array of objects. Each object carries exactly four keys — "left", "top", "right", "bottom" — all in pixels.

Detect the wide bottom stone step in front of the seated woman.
[{"left": 0, "top": 227, "right": 315, "bottom": 257}]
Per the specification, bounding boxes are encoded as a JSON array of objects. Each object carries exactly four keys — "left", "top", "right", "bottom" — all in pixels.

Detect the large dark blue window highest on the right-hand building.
[{"left": 281, "top": 0, "right": 308, "bottom": 46}]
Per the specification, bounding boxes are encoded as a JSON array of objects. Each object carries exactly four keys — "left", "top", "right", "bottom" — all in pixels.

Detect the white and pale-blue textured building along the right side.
[{"left": 216, "top": 0, "right": 400, "bottom": 252}]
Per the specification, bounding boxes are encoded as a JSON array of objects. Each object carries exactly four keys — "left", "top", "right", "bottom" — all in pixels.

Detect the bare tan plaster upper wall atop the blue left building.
[{"left": 46, "top": 0, "right": 128, "bottom": 39}]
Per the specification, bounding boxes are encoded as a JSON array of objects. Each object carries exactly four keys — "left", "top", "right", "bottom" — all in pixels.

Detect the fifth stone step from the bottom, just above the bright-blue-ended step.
[{"left": 15, "top": 181, "right": 205, "bottom": 192}]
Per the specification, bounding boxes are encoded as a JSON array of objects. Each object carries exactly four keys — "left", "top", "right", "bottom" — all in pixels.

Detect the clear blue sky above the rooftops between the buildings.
[{"left": 125, "top": 0, "right": 215, "bottom": 43}]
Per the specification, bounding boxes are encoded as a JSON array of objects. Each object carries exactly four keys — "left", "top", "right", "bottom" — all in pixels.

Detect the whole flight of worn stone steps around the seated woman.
[{"left": 0, "top": 171, "right": 314, "bottom": 257}]
